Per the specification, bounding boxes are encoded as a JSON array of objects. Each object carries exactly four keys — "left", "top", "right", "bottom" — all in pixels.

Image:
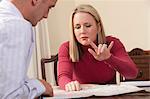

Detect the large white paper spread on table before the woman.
[{"left": 46, "top": 84, "right": 143, "bottom": 99}]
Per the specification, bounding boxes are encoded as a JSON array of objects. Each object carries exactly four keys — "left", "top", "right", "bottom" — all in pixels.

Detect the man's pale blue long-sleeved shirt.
[{"left": 0, "top": 0, "right": 45, "bottom": 99}]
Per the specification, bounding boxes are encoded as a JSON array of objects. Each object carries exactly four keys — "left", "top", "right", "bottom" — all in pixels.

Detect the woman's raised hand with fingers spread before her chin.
[{"left": 88, "top": 40, "right": 114, "bottom": 61}]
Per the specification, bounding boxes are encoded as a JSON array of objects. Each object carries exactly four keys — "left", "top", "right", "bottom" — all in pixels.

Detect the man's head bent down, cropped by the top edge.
[{"left": 11, "top": 0, "right": 57, "bottom": 26}]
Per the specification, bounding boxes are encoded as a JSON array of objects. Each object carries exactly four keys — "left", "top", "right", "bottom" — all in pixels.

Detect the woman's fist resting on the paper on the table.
[{"left": 65, "top": 81, "right": 81, "bottom": 91}]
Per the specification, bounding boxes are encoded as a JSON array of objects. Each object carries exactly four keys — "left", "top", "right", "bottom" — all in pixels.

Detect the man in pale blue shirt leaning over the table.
[{"left": 0, "top": 0, "right": 57, "bottom": 99}]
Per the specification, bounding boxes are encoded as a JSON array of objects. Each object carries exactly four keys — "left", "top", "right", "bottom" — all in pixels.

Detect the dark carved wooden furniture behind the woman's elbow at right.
[{"left": 128, "top": 48, "right": 150, "bottom": 80}]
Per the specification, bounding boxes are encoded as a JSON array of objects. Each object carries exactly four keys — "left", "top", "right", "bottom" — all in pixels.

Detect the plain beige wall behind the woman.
[{"left": 48, "top": 0, "right": 150, "bottom": 54}]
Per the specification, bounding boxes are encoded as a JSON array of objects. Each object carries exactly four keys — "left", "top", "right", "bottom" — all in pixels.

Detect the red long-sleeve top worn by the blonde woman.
[{"left": 57, "top": 36, "right": 138, "bottom": 89}]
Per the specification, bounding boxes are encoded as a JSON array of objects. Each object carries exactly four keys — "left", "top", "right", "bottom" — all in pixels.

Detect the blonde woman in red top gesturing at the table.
[{"left": 58, "top": 5, "right": 138, "bottom": 91}]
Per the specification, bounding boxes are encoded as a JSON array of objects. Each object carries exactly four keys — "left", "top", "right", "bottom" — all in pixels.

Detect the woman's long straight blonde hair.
[{"left": 69, "top": 5, "right": 106, "bottom": 62}]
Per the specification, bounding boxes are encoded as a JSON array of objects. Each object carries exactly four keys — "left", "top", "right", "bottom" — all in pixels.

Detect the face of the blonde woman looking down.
[{"left": 73, "top": 12, "right": 98, "bottom": 46}]
